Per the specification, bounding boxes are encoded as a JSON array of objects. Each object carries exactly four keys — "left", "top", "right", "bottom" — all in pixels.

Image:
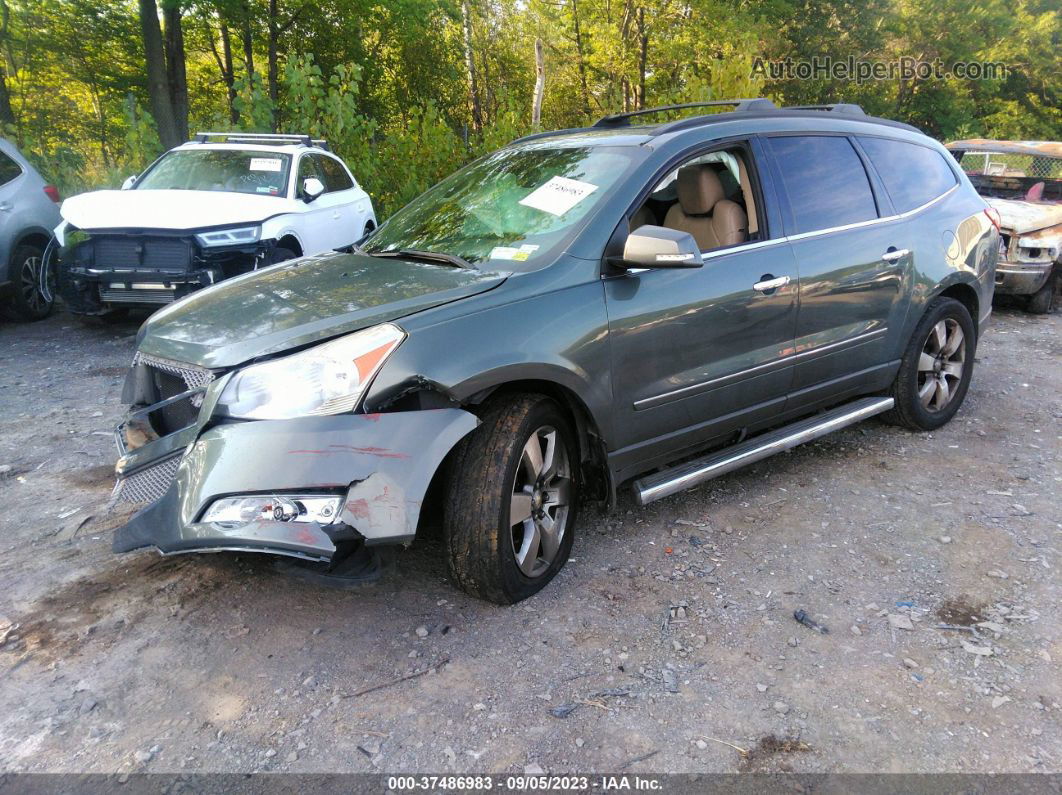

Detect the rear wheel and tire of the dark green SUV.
[{"left": 881, "top": 297, "right": 977, "bottom": 431}]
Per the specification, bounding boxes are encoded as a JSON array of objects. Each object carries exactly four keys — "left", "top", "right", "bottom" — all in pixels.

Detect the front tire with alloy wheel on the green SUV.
[{"left": 444, "top": 395, "right": 580, "bottom": 605}]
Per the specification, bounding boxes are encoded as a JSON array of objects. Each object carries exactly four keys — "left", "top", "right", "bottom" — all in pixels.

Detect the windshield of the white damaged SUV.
[{"left": 134, "top": 149, "right": 291, "bottom": 196}]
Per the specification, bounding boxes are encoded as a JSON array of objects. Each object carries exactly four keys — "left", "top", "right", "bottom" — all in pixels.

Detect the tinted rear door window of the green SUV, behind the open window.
[{"left": 767, "top": 135, "right": 877, "bottom": 235}]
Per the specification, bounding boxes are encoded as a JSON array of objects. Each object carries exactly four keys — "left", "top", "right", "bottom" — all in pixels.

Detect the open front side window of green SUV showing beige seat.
[{"left": 630, "top": 146, "right": 760, "bottom": 252}]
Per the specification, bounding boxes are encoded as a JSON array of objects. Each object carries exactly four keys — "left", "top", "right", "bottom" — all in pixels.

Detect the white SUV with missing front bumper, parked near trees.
[{"left": 56, "top": 133, "right": 376, "bottom": 318}]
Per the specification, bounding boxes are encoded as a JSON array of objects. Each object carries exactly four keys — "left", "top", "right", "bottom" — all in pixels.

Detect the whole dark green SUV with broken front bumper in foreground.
[{"left": 114, "top": 99, "right": 999, "bottom": 604}]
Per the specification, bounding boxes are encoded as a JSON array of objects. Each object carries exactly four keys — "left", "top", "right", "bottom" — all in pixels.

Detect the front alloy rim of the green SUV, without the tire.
[{"left": 509, "top": 426, "right": 571, "bottom": 577}]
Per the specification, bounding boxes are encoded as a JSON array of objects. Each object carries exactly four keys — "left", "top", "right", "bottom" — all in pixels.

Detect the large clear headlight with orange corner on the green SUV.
[{"left": 219, "top": 323, "right": 406, "bottom": 419}]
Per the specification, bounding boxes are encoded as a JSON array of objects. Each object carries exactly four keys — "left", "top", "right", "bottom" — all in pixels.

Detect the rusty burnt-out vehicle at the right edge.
[{"left": 947, "top": 138, "right": 1062, "bottom": 314}]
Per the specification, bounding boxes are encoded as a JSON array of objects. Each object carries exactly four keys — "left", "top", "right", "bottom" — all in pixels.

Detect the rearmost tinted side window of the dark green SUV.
[{"left": 859, "top": 138, "right": 956, "bottom": 212}]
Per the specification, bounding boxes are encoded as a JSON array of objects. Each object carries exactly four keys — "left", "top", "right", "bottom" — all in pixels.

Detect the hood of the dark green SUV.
[{"left": 138, "top": 253, "right": 508, "bottom": 368}]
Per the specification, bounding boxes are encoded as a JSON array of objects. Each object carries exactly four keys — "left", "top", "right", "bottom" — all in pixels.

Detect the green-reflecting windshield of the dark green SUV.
[{"left": 364, "top": 143, "right": 633, "bottom": 270}]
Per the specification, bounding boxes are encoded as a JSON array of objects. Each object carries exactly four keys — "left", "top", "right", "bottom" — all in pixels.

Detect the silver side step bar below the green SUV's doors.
[{"left": 634, "top": 398, "right": 893, "bottom": 505}]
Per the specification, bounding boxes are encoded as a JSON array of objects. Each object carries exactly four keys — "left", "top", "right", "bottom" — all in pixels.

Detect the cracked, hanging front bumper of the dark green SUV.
[{"left": 114, "top": 403, "right": 478, "bottom": 560}]
